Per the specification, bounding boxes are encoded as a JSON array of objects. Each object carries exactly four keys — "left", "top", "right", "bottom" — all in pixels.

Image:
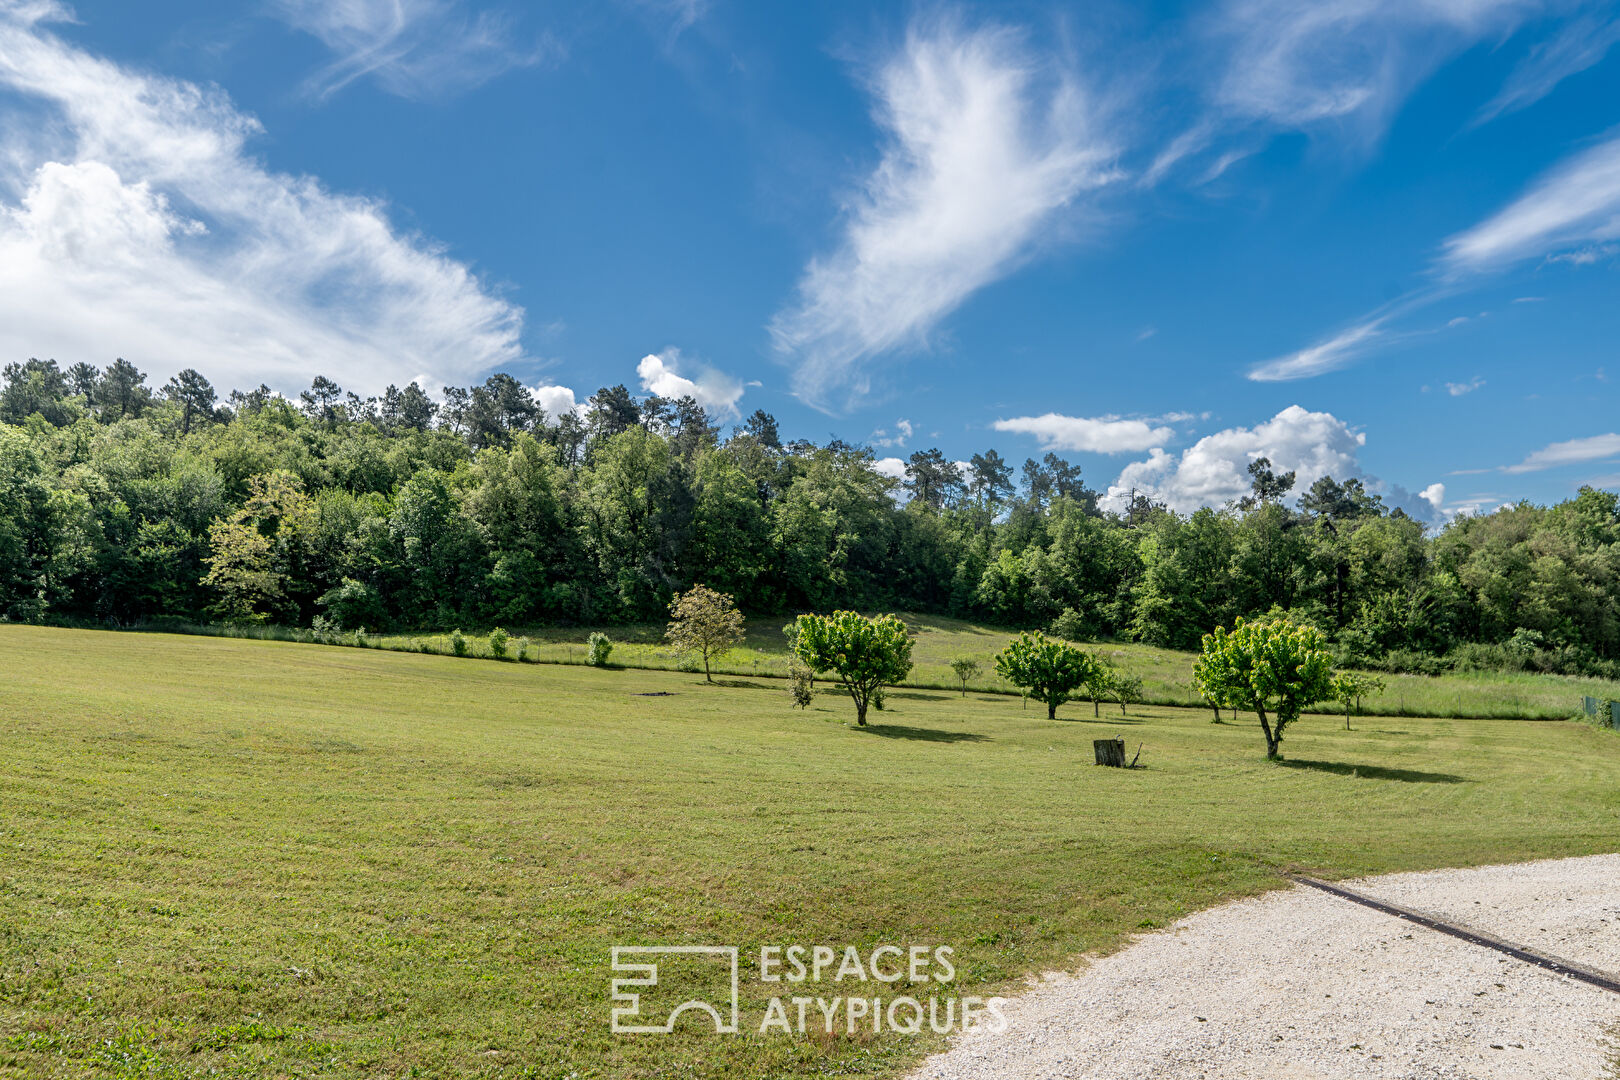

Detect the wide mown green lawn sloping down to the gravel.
[{"left": 0, "top": 625, "right": 1620, "bottom": 1080}]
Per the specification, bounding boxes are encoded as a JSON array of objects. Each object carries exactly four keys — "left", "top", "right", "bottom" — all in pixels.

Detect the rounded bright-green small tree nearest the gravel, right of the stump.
[{"left": 1192, "top": 619, "right": 1335, "bottom": 758}]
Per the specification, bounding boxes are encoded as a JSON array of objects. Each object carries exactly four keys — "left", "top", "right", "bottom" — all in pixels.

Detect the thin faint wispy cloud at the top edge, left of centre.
[{"left": 271, "top": 0, "right": 556, "bottom": 99}]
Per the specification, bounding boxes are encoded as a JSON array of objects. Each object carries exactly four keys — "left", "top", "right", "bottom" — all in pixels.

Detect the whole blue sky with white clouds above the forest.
[{"left": 0, "top": 0, "right": 1620, "bottom": 523}]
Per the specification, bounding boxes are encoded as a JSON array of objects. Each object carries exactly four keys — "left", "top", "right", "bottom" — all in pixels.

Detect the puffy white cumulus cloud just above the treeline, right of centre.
[{"left": 1106, "top": 405, "right": 1367, "bottom": 513}]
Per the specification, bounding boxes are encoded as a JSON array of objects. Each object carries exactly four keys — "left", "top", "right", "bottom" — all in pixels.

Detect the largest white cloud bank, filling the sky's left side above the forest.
[{"left": 0, "top": 3, "right": 523, "bottom": 392}]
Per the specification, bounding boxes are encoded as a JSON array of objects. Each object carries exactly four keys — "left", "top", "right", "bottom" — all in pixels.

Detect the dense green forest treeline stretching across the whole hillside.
[{"left": 0, "top": 361, "right": 1620, "bottom": 674}]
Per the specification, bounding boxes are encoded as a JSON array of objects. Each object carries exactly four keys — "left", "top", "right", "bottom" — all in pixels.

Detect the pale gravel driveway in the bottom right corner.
[{"left": 912, "top": 855, "right": 1620, "bottom": 1080}]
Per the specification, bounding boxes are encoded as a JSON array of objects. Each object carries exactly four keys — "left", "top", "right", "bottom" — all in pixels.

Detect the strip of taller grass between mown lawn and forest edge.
[{"left": 177, "top": 614, "right": 1620, "bottom": 721}]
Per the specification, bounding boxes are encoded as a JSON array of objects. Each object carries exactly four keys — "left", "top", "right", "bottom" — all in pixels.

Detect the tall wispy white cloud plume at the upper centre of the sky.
[{"left": 771, "top": 18, "right": 1116, "bottom": 408}]
